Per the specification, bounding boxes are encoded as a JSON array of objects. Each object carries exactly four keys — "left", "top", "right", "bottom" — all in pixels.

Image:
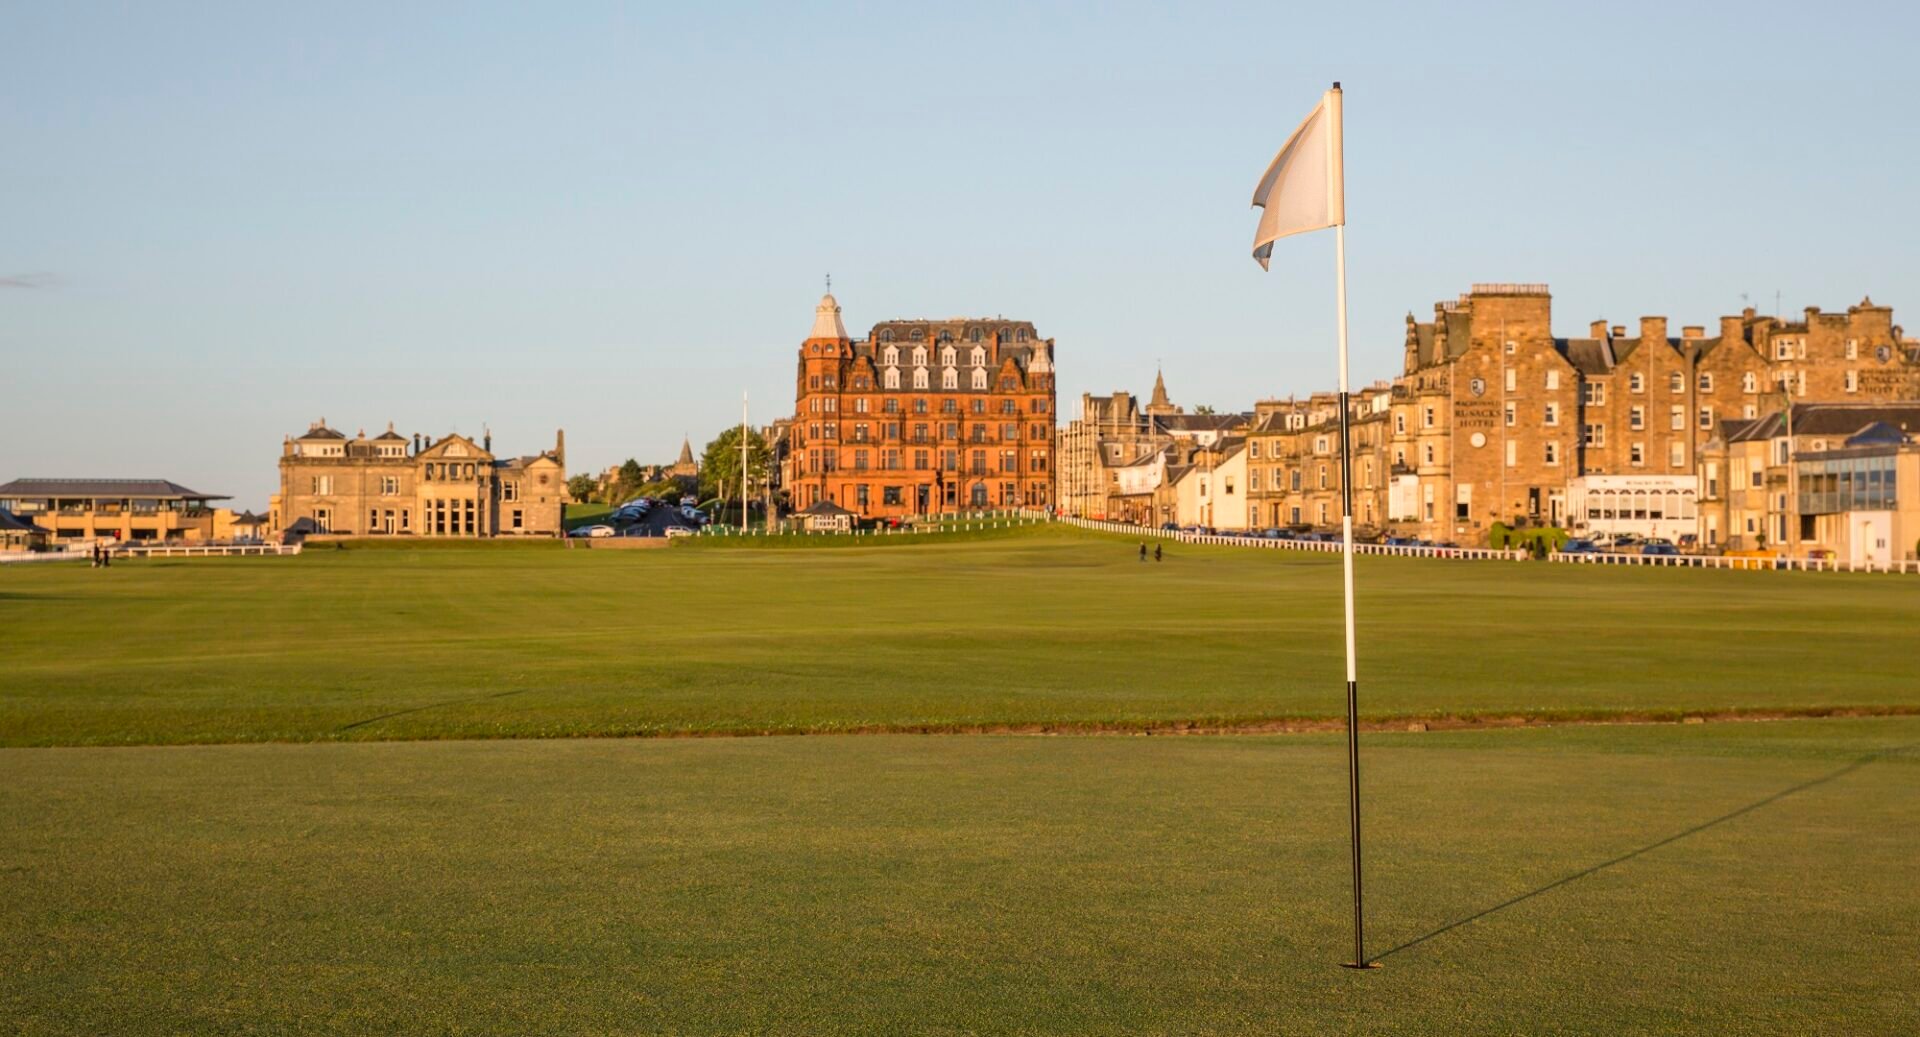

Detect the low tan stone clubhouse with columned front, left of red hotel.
[{"left": 271, "top": 419, "right": 566, "bottom": 538}]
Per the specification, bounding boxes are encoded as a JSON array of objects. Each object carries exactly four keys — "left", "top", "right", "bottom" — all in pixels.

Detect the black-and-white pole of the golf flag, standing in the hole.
[{"left": 1327, "top": 83, "right": 1373, "bottom": 968}]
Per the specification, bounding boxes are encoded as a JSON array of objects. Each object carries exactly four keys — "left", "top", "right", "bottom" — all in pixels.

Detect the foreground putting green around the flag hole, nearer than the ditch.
[{"left": 0, "top": 718, "right": 1920, "bottom": 1035}]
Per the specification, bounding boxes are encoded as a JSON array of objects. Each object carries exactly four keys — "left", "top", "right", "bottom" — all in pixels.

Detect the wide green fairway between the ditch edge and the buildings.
[{"left": 0, "top": 528, "right": 1920, "bottom": 745}]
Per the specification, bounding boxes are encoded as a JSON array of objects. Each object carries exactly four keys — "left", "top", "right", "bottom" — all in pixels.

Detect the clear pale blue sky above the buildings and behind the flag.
[{"left": 0, "top": 2, "right": 1920, "bottom": 507}]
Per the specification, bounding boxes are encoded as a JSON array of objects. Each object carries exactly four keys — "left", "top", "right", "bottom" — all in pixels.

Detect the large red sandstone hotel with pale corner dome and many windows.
[{"left": 785, "top": 296, "right": 1054, "bottom": 519}]
